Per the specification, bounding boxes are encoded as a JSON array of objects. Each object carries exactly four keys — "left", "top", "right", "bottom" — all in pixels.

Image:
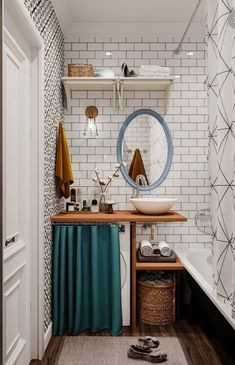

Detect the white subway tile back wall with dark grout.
[{"left": 64, "top": 36, "right": 211, "bottom": 248}]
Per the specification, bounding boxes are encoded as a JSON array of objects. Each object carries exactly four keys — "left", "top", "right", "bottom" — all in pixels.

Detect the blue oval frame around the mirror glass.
[{"left": 117, "top": 109, "right": 173, "bottom": 191}]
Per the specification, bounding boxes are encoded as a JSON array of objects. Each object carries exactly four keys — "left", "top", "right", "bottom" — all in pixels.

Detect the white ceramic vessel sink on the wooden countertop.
[{"left": 130, "top": 197, "right": 178, "bottom": 214}]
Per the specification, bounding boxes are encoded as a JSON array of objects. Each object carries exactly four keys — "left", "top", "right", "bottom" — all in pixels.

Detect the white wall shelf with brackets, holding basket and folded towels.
[{"left": 62, "top": 76, "right": 174, "bottom": 109}]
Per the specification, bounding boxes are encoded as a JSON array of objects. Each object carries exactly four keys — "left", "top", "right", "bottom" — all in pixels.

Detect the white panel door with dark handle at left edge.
[{"left": 3, "top": 29, "right": 31, "bottom": 365}]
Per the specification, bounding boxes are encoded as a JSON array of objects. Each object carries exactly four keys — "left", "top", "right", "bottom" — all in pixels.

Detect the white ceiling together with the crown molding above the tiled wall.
[{"left": 52, "top": 0, "right": 205, "bottom": 34}]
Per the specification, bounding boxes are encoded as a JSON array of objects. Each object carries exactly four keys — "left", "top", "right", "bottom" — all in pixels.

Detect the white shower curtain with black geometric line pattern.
[{"left": 206, "top": 0, "right": 235, "bottom": 317}]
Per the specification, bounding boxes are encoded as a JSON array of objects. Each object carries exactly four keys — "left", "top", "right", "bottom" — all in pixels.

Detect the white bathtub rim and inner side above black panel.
[{"left": 175, "top": 249, "right": 235, "bottom": 329}]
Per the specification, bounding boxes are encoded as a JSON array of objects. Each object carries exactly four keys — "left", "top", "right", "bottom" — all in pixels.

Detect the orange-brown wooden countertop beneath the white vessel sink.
[{"left": 51, "top": 210, "right": 187, "bottom": 223}]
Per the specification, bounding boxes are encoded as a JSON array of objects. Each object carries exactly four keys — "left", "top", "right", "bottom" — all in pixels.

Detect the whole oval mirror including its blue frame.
[{"left": 117, "top": 109, "right": 173, "bottom": 191}]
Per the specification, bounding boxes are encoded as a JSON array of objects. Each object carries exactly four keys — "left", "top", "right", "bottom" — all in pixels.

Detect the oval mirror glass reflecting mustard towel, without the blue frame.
[{"left": 123, "top": 114, "right": 168, "bottom": 185}]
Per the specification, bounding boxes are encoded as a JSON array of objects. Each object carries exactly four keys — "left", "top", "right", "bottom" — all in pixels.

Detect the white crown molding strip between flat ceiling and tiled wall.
[{"left": 65, "top": 22, "right": 205, "bottom": 38}]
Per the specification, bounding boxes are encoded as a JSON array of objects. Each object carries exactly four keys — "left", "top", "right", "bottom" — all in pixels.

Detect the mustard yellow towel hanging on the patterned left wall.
[{"left": 55, "top": 123, "right": 73, "bottom": 198}]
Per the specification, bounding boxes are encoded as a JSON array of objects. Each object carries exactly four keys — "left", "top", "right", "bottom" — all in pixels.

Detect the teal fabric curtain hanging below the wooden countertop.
[{"left": 52, "top": 224, "right": 122, "bottom": 336}]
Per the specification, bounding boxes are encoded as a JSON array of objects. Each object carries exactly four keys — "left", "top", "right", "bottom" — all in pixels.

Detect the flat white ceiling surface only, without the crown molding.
[{"left": 67, "top": 0, "right": 204, "bottom": 23}]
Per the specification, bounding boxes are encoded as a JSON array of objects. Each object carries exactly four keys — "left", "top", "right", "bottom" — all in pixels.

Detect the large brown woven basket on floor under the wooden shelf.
[{"left": 137, "top": 276, "right": 176, "bottom": 325}]
